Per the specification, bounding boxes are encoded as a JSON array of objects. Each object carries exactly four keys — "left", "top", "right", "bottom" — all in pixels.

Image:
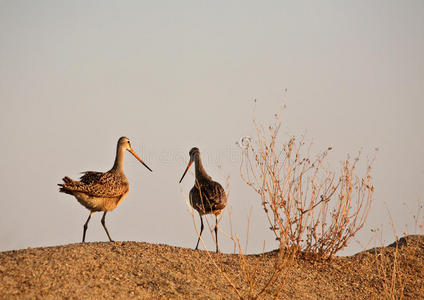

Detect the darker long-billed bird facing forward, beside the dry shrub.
[{"left": 180, "top": 147, "right": 228, "bottom": 252}]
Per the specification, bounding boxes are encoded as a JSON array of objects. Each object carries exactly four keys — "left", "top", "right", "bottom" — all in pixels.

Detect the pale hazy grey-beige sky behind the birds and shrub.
[{"left": 0, "top": 0, "right": 424, "bottom": 254}]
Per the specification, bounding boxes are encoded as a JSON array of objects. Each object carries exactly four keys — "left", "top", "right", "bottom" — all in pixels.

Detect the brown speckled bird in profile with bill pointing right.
[{"left": 58, "top": 136, "right": 153, "bottom": 243}]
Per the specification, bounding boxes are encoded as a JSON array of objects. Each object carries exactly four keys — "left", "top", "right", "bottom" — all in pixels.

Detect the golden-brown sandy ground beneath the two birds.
[{"left": 0, "top": 236, "right": 424, "bottom": 299}]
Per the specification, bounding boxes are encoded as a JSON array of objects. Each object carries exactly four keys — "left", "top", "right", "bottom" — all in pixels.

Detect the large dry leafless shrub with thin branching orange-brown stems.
[{"left": 239, "top": 102, "right": 375, "bottom": 258}]
